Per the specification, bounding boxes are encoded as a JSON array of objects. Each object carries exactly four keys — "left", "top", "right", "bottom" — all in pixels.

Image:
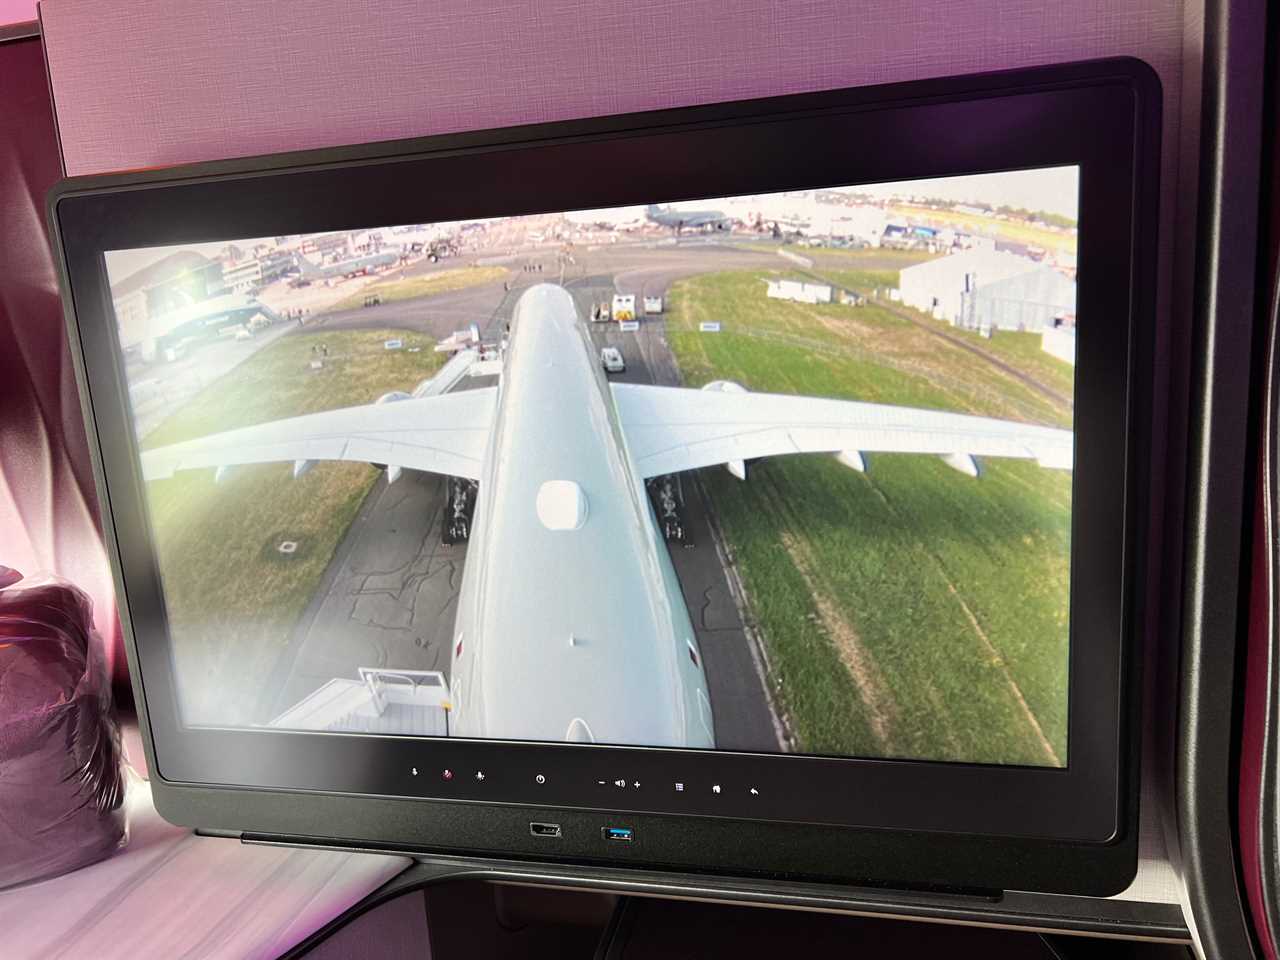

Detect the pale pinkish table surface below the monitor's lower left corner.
[{"left": 0, "top": 777, "right": 411, "bottom": 960}]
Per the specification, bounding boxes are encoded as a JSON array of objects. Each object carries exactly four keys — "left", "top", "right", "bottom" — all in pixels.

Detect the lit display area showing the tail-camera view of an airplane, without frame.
[{"left": 106, "top": 166, "right": 1075, "bottom": 767}]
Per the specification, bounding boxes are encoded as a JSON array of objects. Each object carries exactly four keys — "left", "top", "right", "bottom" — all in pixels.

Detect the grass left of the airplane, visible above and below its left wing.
[{"left": 142, "top": 330, "right": 440, "bottom": 723}]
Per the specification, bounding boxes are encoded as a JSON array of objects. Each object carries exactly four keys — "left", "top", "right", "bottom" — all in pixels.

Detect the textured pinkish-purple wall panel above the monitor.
[{"left": 41, "top": 0, "right": 1181, "bottom": 174}]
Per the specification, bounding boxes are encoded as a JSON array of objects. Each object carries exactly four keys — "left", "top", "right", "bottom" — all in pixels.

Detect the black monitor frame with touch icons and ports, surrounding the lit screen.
[{"left": 49, "top": 59, "right": 1161, "bottom": 893}]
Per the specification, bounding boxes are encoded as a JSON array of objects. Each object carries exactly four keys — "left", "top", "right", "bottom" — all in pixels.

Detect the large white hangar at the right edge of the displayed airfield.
[{"left": 899, "top": 248, "right": 1075, "bottom": 334}]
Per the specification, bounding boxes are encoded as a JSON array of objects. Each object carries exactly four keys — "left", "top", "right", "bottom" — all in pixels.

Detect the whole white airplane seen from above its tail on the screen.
[{"left": 142, "top": 284, "right": 1073, "bottom": 748}]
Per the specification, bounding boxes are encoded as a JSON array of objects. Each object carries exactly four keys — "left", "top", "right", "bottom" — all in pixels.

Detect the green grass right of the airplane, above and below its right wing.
[{"left": 667, "top": 271, "right": 1070, "bottom": 764}]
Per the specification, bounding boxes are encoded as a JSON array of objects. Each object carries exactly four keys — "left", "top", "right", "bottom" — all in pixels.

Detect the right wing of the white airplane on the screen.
[{"left": 612, "top": 383, "right": 1074, "bottom": 477}]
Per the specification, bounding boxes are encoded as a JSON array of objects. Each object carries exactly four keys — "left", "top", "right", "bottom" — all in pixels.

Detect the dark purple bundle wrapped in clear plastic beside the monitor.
[{"left": 0, "top": 566, "right": 125, "bottom": 888}]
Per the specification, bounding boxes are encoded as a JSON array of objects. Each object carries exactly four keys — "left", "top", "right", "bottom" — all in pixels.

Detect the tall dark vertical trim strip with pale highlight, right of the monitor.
[{"left": 1175, "top": 0, "right": 1266, "bottom": 960}]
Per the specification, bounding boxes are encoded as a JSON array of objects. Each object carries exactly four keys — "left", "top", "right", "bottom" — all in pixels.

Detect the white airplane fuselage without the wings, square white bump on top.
[{"left": 449, "top": 284, "right": 714, "bottom": 746}]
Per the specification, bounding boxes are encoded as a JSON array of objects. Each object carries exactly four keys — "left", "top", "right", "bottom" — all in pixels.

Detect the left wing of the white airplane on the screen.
[{"left": 142, "top": 387, "right": 497, "bottom": 480}]
